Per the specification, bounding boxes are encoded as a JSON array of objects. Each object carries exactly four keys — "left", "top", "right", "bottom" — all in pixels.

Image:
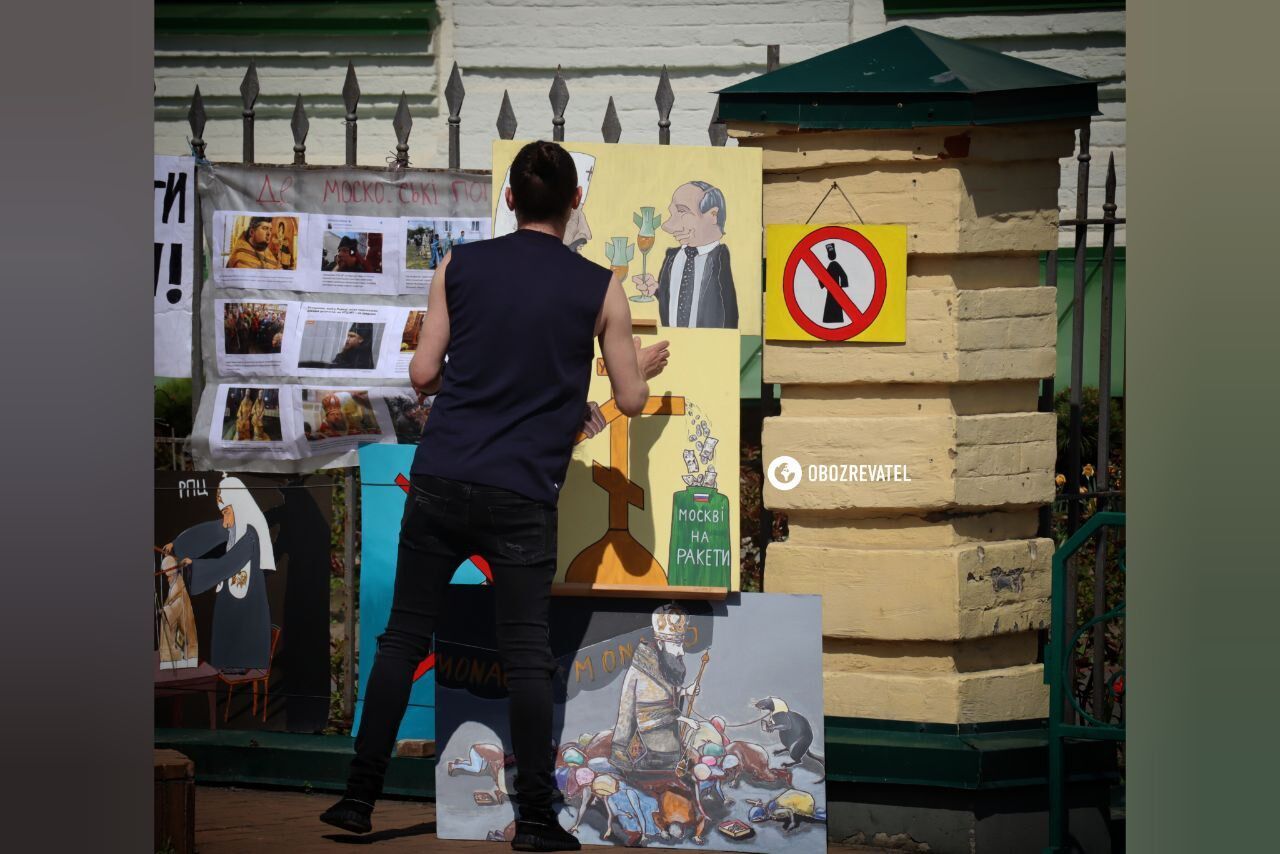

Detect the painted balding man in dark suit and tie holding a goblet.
[{"left": 631, "top": 181, "right": 737, "bottom": 329}]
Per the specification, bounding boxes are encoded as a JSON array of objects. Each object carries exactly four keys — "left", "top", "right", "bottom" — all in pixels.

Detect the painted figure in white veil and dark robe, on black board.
[{"left": 163, "top": 478, "right": 275, "bottom": 672}]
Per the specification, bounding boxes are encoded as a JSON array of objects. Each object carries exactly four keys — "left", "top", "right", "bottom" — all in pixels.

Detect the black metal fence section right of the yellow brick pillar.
[{"left": 1039, "top": 124, "right": 1126, "bottom": 851}]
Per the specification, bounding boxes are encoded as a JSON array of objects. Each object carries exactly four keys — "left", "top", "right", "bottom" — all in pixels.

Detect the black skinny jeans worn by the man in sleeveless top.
[{"left": 347, "top": 475, "right": 557, "bottom": 810}]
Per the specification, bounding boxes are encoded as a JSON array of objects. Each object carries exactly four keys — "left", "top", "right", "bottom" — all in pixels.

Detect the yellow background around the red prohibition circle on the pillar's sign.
[{"left": 764, "top": 223, "right": 906, "bottom": 343}]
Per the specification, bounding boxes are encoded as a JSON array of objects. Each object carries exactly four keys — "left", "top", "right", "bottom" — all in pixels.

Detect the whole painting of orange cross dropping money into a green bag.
[{"left": 558, "top": 328, "right": 739, "bottom": 597}]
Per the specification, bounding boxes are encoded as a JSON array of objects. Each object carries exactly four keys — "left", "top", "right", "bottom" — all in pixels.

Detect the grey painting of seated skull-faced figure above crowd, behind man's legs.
[{"left": 435, "top": 588, "right": 827, "bottom": 854}]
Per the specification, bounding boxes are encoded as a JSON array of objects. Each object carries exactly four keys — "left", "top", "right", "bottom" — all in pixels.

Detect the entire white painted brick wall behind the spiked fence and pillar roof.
[{"left": 156, "top": 0, "right": 1125, "bottom": 243}]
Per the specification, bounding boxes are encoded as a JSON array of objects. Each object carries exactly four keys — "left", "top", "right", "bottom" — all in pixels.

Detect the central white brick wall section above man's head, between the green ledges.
[{"left": 442, "top": 0, "right": 850, "bottom": 166}]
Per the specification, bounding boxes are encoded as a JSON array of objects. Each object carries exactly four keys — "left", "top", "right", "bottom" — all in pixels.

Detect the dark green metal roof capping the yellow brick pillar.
[{"left": 719, "top": 27, "right": 1098, "bottom": 129}]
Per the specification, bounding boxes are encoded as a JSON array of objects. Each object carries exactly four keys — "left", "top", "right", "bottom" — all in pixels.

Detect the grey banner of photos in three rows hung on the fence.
[{"left": 193, "top": 164, "right": 492, "bottom": 471}]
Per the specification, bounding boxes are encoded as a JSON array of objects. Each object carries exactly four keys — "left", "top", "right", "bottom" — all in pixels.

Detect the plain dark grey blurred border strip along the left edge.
[{"left": 0, "top": 0, "right": 155, "bottom": 854}]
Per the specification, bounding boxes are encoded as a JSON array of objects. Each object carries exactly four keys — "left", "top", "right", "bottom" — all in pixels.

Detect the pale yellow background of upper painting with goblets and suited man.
[{"left": 493, "top": 140, "right": 762, "bottom": 335}]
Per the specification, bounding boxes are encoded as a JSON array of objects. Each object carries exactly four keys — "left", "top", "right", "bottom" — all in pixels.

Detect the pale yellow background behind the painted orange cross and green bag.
[{"left": 557, "top": 323, "right": 741, "bottom": 590}]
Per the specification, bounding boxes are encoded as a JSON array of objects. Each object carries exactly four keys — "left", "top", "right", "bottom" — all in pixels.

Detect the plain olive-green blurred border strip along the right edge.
[{"left": 1126, "top": 0, "right": 1280, "bottom": 854}]
